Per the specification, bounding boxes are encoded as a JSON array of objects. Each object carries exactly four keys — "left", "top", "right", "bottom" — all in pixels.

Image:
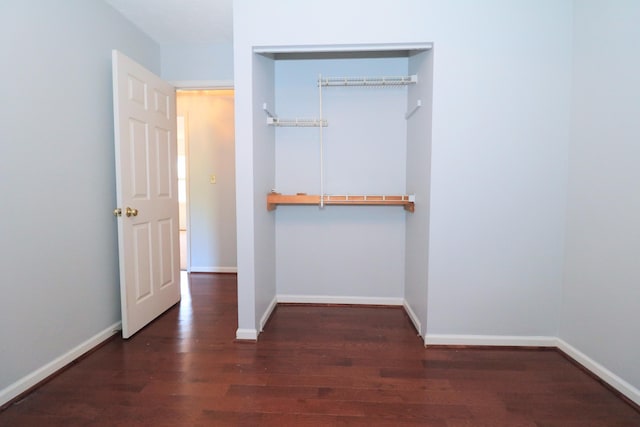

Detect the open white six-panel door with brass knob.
[{"left": 112, "top": 50, "right": 180, "bottom": 338}]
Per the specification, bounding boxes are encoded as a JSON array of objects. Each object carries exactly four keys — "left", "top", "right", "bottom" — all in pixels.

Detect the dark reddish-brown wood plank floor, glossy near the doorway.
[{"left": 0, "top": 274, "right": 640, "bottom": 427}]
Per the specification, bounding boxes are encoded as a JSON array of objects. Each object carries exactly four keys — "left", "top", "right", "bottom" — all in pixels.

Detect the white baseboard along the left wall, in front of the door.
[{"left": 0, "top": 322, "right": 122, "bottom": 405}]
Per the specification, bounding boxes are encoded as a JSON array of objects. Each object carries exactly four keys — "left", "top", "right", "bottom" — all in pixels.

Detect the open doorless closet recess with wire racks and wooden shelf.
[{"left": 252, "top": 43, "right": 433, "bottom": 342}]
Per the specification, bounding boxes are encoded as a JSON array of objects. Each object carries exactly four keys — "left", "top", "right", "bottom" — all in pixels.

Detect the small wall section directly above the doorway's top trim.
[{"left": 161, "top": 43, "right": 233, "bottom": 82}]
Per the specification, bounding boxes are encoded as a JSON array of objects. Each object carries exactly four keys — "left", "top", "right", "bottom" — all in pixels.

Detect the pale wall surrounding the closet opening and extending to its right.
[{"left": 234, "top": 0, "right": 572, "bottom": 336}]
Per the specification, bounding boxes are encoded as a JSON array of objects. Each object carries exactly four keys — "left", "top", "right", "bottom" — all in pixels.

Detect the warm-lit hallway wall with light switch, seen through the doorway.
[{"left": 177, "top": 89, "right": 237, "bottom": 272}]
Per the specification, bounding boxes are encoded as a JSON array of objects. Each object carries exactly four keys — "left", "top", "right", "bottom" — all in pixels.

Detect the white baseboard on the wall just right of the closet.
[{"left": 424, "top": 334, "right": 557, "bottom": 347}]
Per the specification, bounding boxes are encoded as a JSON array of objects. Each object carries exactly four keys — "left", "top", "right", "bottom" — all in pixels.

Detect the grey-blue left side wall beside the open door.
[{"left": 0, "top": 0, "right": 160, "bottom": 403}]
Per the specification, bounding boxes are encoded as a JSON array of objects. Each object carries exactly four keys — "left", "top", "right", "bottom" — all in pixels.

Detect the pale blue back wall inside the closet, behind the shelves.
[{"left": 275, "top": 58, "right": 407, "bottom": 304}]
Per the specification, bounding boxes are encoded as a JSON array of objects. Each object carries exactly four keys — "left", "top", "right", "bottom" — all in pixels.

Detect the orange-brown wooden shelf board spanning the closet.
[{"left": 267, "top": 193, "right": 415, "bottom": 212}]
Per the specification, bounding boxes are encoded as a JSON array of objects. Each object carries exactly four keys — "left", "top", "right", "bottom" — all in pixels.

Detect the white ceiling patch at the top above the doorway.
[{"left": 105, "top": 0, "right": 233, "bottom": 45}]
